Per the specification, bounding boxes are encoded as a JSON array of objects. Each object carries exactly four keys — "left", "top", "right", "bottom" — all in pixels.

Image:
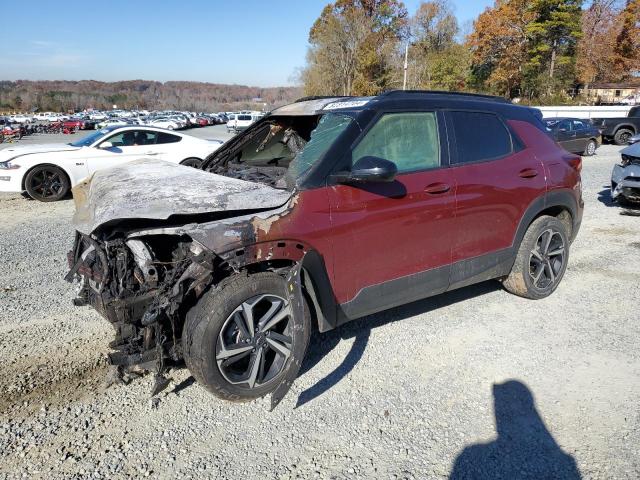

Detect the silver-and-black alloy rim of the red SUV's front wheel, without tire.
[{"left": 216, "top": 294, "right": 293, "bottom": 389}]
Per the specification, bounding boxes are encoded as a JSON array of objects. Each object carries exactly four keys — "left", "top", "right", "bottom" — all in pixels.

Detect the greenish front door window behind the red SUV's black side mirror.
[{"left": 352, "top": 112, "right": 440, "bottom": 173}]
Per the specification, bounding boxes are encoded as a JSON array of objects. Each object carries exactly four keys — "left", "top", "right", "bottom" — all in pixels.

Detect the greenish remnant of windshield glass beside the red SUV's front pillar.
[{"left": 287, "top": 113, "right": 353, "bottom": 179}]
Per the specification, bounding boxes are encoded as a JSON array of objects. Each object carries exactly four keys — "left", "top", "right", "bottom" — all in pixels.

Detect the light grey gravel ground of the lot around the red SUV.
[{"left": 0, "top": 133, "right": 640, "bottom": 479}]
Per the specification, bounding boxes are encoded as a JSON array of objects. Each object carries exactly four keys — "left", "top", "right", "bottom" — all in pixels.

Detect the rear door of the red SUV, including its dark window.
[{"left": 447, "top": 111, "right": 546, "bottom": 287}]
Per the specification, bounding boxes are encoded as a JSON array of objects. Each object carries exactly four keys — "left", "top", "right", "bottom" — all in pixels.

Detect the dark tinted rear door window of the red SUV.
[{"left": 451, "top": 112, "right": 513, "bottom": 163}]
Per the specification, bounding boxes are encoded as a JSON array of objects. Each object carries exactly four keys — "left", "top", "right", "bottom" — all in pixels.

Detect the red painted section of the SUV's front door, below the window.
[{"left": 329, "top": 168, "right": 455, "bottom": 303}]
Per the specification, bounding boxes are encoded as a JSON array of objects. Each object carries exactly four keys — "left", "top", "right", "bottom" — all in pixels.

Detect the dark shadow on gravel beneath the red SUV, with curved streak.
[{"left": 295, "top": 281, "right": 500, "bottom": 408}]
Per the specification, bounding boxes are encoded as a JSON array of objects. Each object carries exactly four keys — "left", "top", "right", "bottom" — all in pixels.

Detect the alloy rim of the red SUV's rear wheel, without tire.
[{"left": 529, "top": 228, "right": 566, "bottom": 290}]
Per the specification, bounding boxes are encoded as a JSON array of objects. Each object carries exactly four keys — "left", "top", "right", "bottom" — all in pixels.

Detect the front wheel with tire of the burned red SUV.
[{"left": 182, "top": 272, "right": 311, "bottom": 402}]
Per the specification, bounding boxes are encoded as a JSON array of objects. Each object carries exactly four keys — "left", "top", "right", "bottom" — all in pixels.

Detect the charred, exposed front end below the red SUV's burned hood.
[{"left": 66, "top": 232, "right": 216, "bottom": 393}]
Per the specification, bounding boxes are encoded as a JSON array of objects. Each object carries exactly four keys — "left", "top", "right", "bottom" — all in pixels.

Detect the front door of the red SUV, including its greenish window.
[{"left": 329, "top": 112, "right": 455, "bottom": 318}]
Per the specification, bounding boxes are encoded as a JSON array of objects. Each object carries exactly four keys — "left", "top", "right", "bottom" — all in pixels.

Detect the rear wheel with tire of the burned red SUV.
[{"left": 502, "top": 215, "right": 569, "bottom": 300}]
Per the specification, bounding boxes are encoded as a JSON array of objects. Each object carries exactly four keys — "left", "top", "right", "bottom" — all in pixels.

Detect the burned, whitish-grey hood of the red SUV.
[{"left": 73, "top": 159, "right": 291, "bottom": 234}]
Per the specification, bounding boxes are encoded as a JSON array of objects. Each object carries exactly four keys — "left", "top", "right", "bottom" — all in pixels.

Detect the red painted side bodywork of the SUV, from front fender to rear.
[{"left": 252, "top": 121, "right": 581, "bottom": 303}]
